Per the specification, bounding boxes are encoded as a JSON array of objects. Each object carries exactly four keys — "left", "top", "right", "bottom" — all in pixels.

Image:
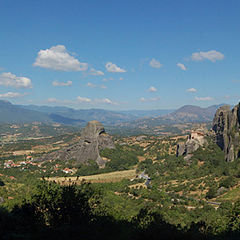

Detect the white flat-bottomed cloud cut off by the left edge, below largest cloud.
[{"left": 0, "top": 72, "right": 32, "bottom": 88}]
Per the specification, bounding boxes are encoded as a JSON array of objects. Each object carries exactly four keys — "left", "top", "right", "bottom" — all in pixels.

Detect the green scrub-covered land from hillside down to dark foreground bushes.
[{"left": 0, "top": 135, "right": 240, "bottom": 239}]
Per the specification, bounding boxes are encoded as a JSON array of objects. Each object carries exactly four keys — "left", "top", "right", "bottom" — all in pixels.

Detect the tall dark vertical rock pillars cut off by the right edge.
[{"left": 212, "top": 104, "right": 240, "bottom": 162}]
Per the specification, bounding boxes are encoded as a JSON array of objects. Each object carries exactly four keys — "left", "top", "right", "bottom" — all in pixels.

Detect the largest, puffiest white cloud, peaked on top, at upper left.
[{"left": 33, "top": 45, "right": 88, "bottom": 71}]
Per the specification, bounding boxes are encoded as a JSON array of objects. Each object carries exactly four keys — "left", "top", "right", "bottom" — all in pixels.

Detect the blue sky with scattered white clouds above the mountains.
[{"left": 0, "top": 0, "right": 240, "bottom": 110}]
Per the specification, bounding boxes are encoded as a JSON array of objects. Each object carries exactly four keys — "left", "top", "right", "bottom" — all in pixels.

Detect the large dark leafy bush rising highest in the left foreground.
[{"left": 13, "top": 182, "right": 93, "bottom": 226}]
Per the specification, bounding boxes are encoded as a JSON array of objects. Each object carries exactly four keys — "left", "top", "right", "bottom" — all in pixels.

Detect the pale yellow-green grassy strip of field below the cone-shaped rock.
[{"left": 48, "top": 169, "right": 136, "bottom": 184}]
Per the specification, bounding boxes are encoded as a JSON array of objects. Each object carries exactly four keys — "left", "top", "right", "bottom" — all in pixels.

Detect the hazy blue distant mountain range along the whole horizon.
[{"left": 0, "top": 100, "right": 229, "bottom": 126}]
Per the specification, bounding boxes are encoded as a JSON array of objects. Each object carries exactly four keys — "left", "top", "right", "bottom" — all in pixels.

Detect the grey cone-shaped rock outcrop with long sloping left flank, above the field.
[{"left": 40, "top": 121, "right": 115, "bottom": 166}]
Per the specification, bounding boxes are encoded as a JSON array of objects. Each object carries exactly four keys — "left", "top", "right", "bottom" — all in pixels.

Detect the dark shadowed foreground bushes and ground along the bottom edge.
[{"left": 0, "top": 183, "right": 240, "bottom": 240}]
